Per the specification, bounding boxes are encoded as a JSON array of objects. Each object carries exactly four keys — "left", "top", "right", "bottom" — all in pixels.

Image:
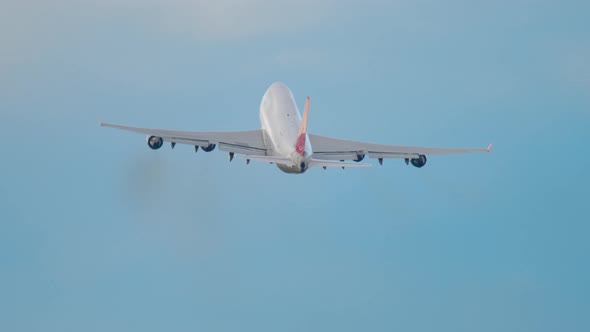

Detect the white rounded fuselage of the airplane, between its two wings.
[{"left": 260, "top": 82, "right": 312, "bottom": 173}]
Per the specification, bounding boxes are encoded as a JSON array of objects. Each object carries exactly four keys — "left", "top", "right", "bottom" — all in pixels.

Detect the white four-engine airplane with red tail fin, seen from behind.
[{"left": 99, "top": 82, "right": 492, "bottom": 174}]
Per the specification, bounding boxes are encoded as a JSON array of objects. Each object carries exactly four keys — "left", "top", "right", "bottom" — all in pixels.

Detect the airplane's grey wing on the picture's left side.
[{"left": 99, "top": 121, "right": 267, "bottom": 156}]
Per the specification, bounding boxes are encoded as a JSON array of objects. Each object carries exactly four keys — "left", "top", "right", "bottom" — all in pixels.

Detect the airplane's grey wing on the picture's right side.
[{"left": 308, "top": 134, "right": 492, "bottom": 162}]
